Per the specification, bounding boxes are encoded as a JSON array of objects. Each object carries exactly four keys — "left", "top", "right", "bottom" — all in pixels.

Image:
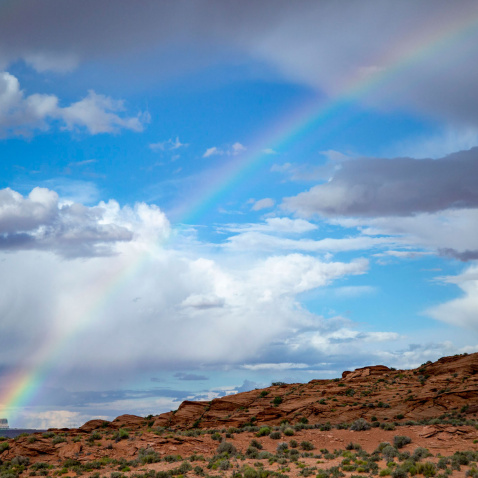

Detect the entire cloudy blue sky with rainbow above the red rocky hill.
[{"left": 0, "top": 0, "right": 478, "bottom": 428}]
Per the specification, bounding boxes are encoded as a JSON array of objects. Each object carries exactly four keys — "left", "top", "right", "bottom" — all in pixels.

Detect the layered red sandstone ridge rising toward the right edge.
[{"left": 154, "top": 354, "right": 478, "bottom": 429}]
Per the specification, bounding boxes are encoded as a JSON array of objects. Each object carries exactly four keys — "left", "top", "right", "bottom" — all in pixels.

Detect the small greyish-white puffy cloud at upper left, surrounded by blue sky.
[{"left": 0, "top": 72, "right": 149, "bottom": 136}]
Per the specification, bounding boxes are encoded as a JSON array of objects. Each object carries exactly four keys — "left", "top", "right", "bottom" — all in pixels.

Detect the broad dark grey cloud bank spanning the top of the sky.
[{"left": 0, "top": 0, "right": 478, "bottom": 124}]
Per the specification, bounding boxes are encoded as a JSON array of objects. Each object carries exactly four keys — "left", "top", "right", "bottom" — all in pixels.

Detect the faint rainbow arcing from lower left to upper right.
[{"left": 0, "top": 7, "right": 478, "bottom": 423}]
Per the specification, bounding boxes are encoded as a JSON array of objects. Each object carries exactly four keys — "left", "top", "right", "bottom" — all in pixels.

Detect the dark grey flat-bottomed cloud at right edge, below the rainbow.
[{"left": 283, "top": 148, "right": 478, "bottom": 217}]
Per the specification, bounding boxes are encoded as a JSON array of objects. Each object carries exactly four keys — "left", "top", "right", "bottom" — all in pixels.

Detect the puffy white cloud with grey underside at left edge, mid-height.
[{"left": 0, "top": 187, "right": 169, "bottom": 257}]
